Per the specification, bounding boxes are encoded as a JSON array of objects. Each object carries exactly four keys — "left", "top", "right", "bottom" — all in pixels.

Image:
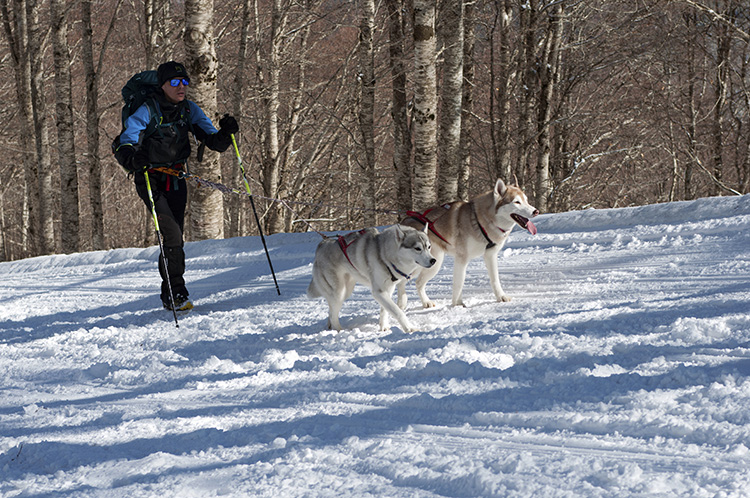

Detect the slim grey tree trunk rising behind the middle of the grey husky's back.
[{"left": 359, "top": 0, "right": 377, "bottom": 226}]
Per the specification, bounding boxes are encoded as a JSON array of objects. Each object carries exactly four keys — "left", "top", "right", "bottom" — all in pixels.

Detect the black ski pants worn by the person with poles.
[{"left": 135, "top": 172, "right": 188, "bottom": 302}]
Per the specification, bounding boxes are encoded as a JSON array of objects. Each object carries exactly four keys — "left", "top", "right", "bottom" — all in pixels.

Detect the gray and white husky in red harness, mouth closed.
[{"left": 307, "top": 225, "right": 435, "bottom": 332}]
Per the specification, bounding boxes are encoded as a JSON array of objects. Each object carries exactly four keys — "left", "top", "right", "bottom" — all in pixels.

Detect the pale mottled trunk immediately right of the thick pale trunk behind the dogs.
[{"left": 438, "top": 0, "right": 464, "bottom": 202}]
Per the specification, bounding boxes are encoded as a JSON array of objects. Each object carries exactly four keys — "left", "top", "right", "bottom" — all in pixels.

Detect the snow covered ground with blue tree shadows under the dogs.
[{"left": 0, "top": 195, "right": 750, "bottom": 498}]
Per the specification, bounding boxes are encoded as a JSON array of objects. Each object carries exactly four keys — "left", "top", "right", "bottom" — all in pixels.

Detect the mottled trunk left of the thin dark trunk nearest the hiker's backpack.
[{"left": 50, "top": 0, "right": 80, "bottom": 254}]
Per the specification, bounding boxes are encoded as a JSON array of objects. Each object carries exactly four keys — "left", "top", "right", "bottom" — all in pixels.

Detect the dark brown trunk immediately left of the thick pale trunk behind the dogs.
[{"left": 386, "top": 0, "right": 413, "bottom": 210}]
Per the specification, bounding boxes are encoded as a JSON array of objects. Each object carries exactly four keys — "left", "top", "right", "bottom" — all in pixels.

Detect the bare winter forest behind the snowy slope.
[{"left": 0, "top": 0, "right": 750, "bottom": 260}]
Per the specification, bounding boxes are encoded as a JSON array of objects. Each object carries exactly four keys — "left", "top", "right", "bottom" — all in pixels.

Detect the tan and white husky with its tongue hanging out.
[{"left": 398, "top": 180, "right": 539, "bottom": 309}]
